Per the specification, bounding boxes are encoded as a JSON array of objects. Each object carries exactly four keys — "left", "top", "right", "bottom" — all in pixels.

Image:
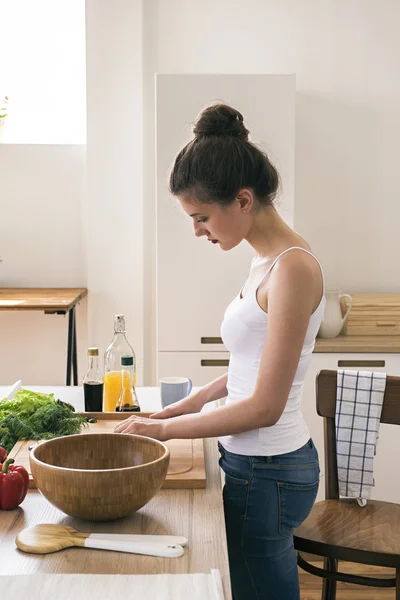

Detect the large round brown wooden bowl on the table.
[{"left": 29, "top": 433, "right": 169, "bottom": 521}]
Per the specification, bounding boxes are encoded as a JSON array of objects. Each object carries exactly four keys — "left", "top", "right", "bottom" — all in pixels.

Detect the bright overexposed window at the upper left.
[{"left": 0, "top": 0, "right": 86, "bottom": 144}]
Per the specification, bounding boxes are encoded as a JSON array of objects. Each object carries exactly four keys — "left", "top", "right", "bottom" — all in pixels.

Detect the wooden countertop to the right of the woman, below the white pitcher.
[{"left": 314, "top": 335, "right": 400, "bottom": 354}]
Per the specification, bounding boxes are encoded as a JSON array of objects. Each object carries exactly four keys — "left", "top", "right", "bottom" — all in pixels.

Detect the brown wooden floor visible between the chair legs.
[{"left": 299, "top": 562, "right": 396, "bottom": 600}]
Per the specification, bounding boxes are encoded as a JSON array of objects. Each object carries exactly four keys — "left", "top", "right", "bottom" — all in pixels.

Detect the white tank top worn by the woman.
[{"left": 219, "top": 246, "right": 325, "bottom": 456}]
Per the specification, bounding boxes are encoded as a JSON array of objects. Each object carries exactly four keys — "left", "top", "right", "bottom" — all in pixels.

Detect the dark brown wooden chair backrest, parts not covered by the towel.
[{"left": 316, "top": 370, "right": 400, "bottom": 499}]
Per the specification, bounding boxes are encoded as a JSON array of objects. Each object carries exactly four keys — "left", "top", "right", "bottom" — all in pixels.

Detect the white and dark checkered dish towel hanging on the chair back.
[{"left": 335, "top": 369, "right": 386, "bottom": 505}]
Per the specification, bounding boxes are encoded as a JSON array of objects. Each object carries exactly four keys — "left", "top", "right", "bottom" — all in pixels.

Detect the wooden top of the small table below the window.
[{"left": 0, "top": 288, "right": 87, "bottom": 312}]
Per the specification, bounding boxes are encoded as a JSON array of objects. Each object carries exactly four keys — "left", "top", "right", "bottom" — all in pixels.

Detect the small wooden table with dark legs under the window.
[{"left": 0, "top": 288, "right": 87, "bottom": 385}]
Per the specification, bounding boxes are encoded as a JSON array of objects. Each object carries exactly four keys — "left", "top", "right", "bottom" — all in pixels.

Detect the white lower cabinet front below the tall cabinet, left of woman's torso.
[{"left": 158, "top": 352, "right": 229, "bottom": 386}]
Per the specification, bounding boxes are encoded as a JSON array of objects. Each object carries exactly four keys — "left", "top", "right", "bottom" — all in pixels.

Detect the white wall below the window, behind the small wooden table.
[{"left": 0, "top": 144, "right": 87, "bottom": 384}]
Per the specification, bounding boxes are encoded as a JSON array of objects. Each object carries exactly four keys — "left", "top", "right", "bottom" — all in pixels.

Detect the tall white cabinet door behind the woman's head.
[{"left": 156, "top": 75, "right": 295, "bottom": 351}]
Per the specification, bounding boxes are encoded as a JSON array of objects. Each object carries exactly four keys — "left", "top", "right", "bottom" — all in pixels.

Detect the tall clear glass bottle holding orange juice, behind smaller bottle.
[{"left": 103, "top": 315, "right": 136, "bottom": 412}]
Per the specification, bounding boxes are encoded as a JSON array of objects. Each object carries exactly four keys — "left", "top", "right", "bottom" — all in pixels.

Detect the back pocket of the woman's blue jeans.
[{"left": 277, "top": 481, "right": 319, "bottom": 537}]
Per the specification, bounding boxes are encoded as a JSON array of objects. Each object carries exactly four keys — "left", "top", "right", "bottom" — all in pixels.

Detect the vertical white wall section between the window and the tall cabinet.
[{"left": 83, "top": 0, "right": 144, "bottom": 385}]
